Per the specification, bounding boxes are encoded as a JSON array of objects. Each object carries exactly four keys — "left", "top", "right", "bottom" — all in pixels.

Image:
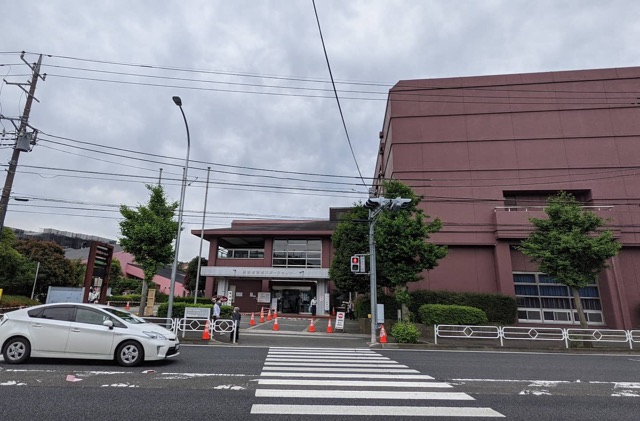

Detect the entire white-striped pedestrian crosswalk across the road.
[{"left": 251, "top": 347, "right": 503, "bottom": 418}]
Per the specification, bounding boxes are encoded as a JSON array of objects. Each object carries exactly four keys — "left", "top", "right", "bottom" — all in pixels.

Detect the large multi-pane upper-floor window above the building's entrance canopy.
[{"left": 272, "top": 240, "right": 322, "bottom": 268}]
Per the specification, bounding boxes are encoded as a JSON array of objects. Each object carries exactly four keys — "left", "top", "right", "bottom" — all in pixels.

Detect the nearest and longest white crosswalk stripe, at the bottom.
[{"left": 251, "top": 404, "right": 504, "bottom": 418}]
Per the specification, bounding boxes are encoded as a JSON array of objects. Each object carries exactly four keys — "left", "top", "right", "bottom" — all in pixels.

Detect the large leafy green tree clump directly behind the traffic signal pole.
[{"left": 329, "top": 180, "right": 447, "bottom": 316}]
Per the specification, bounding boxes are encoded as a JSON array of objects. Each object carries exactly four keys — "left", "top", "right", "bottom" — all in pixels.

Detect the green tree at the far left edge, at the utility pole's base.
[{"left": 0, "top": 227, "right": 37, "bottom": 297}]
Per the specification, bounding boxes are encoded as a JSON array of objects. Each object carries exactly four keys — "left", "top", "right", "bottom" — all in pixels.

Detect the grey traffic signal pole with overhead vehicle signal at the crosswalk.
[{"left": 364, "top": 197, "right": 411, "bottom": 344}]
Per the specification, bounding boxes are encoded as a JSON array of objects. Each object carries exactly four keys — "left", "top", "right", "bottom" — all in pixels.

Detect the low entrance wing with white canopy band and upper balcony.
[{"left": 198, "top": 208, "right": 352, "bottom": 315}]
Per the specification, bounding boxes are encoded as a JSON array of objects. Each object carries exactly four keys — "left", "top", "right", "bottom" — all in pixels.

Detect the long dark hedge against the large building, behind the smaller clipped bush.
[{"left": 409, "top": 290, "right": 518, "bottom": 325}]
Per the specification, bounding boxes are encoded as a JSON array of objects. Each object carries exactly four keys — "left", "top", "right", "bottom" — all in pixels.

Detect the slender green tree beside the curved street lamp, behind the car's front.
[{"left": 119, "top": 185, "right": 178, "bottom": 316}]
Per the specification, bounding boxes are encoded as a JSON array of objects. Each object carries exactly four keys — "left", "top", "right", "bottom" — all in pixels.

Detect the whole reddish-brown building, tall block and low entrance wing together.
[{"left": 192, "top": 68, "right": 640, "bottom": 329}]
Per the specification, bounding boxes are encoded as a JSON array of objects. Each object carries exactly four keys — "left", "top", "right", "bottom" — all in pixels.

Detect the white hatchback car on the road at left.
[{"left": 0, "top": 303, "right": 180, "bottom": 367}]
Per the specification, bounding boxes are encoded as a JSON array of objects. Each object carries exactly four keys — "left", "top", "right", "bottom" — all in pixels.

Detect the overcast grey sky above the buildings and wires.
[{"left": 0, "top": 0, "right": 640, "bottom": 261}]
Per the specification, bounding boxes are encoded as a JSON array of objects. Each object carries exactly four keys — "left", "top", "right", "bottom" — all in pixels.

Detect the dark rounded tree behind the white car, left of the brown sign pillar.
[{"left": 16, "top": 240, "right": 78, "bottom": 297}]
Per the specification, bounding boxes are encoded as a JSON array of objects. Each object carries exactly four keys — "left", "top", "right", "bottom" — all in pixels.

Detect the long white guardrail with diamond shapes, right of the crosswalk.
[{"left": 433, "top": 325, "right": 640, "bottom": 349}]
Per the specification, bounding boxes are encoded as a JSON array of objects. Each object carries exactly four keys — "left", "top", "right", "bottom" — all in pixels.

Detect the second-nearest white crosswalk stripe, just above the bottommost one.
[{"left": 256, "top": 389, "right": 475, "bottom": 401}]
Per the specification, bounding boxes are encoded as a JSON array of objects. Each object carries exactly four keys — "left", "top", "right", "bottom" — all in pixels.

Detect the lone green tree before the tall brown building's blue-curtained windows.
[{"left": 518, "top": 192, "right": 622, "bottom": 329}]
